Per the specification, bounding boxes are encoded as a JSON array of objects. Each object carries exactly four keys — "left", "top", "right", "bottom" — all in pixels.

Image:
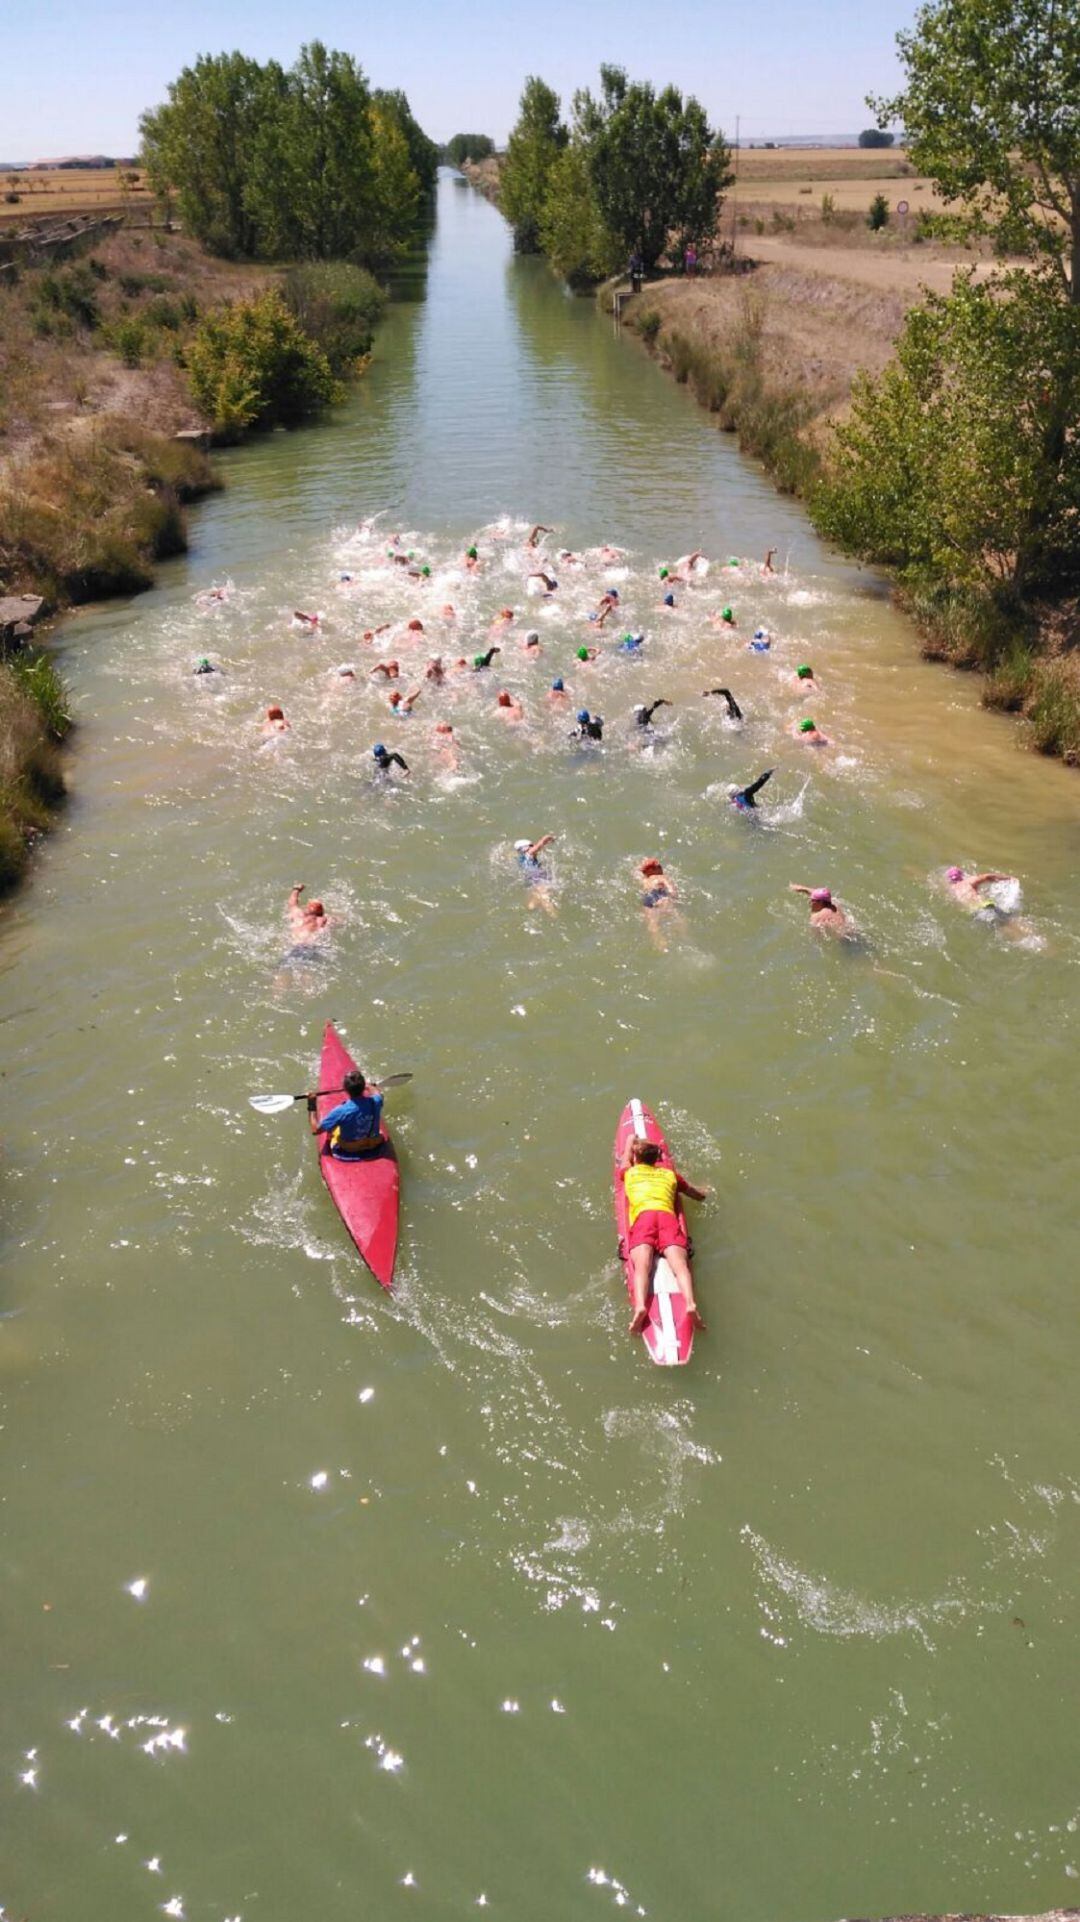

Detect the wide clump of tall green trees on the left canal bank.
[{"left": 140, "top": 40, "right": 438, "bottom": 267}]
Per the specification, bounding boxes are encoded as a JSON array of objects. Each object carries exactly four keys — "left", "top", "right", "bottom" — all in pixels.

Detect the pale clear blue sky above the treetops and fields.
[{"left": 0, "top": 0, "right": 915, "bottom": 160}]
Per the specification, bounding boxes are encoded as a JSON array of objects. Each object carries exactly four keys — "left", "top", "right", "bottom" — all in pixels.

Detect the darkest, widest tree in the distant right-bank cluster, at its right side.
[{"left": 575, "top": 67, "right": 732, "bottom": 267}]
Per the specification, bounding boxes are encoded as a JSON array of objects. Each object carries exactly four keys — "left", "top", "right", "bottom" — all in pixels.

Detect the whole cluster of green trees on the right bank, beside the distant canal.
[{"left": 500, "top": 65, "right": 732, "bottom": 286}]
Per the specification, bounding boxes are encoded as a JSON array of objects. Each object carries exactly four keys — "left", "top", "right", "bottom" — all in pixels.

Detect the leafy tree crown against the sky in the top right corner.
[{"left": 869, "top": 0, "right": 1080, "bottom": 304}]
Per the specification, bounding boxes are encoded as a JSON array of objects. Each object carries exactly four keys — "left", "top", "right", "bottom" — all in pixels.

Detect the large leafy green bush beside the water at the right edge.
[{"left": 815, "top": 269, "right": 1080, "bottom": 592}]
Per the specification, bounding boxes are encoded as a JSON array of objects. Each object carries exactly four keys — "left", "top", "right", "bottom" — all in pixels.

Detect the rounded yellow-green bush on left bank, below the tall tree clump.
[{"left": 188, "top": 292, "right": 338, "bottom": 440}]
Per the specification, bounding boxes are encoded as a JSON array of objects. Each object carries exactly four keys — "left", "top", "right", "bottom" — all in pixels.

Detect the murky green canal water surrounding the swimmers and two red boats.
[{"left": 0, "top": 177, "right": 1080, "bottom": 1922}]
